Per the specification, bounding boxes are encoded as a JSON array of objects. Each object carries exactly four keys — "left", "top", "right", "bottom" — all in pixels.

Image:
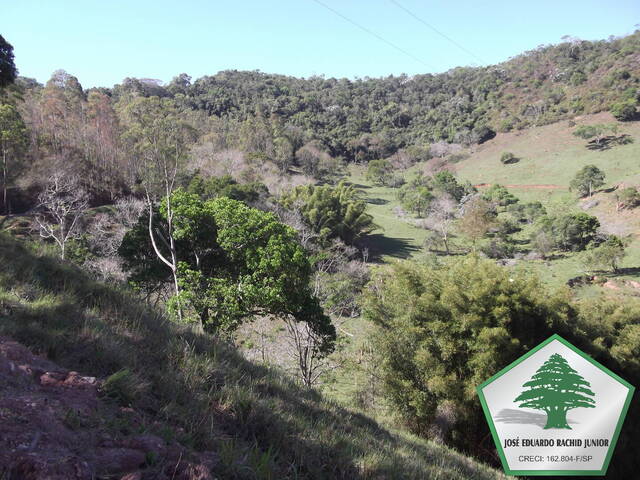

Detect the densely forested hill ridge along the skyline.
[{"left": 28, "top": 31, "right": 640, "bottom": 160}]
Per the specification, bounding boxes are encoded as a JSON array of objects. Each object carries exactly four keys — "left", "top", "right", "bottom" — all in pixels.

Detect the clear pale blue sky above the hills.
[{"left": 0, "top": 0, "right": 640, "bottom": 88}]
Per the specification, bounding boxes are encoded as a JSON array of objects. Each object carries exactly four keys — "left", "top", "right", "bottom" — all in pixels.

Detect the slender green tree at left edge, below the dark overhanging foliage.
[{"left": 0, "top": 104, "right": 28, "bottom": 213}]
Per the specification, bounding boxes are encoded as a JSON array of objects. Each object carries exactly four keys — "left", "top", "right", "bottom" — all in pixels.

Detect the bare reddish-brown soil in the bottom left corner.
[{"left": 0, "top": 337, "right": 216, "bottom": 480}]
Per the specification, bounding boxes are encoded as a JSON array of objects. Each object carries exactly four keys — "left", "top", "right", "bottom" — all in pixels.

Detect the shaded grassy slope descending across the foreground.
[{"left": 0, "top": 234, "right": 505, "bottom": 479}]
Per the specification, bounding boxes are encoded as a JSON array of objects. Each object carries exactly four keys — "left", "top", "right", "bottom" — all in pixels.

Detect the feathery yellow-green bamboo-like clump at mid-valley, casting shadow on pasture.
[{"left": 280, "top": 182, "right": 377, "bottom": 245}]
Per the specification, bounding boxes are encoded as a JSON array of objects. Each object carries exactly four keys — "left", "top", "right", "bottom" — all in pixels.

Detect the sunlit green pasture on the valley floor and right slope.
[{"left": 349, "top": 113, "right": 640, "bottom": 296}]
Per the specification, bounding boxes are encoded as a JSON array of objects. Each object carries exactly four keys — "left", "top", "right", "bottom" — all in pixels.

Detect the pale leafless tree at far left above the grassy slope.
[{"left": 36, "top": 172, "right": 89, "bottom": 259}]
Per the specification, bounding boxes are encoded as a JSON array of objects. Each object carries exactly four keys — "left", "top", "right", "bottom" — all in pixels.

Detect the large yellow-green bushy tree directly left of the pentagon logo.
[{"left": 364, "top": 256, "right": 575, "bottom": 453}]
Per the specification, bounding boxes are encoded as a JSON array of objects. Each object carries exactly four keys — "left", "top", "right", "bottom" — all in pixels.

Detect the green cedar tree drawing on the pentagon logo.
[{"left": 514, "top": 353, "right": 596, "bottom": 429}]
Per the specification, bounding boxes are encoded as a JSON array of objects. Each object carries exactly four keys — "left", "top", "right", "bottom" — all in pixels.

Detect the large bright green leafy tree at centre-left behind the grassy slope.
[{"left": 119, "top": 189, "right": 335, "bottom": 353}]
